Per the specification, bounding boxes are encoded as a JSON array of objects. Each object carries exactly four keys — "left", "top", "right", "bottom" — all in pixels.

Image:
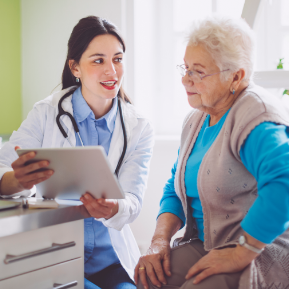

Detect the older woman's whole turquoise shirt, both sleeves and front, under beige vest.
[{"left": 159, "top": 112, "right": 289, "bottom": 243}]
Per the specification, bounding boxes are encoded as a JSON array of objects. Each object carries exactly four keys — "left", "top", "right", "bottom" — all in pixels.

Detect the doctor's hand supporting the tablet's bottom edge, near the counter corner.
[{"left": 80, "top": 193, "right": 118, "bottom": 219}]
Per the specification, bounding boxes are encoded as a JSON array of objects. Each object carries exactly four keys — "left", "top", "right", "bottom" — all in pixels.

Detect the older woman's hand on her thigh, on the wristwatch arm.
[{"left": 186, "top": 245, "right": 258, "bottom": 284}]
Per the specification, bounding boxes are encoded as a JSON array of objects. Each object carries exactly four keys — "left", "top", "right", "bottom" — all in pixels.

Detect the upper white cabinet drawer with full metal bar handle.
[{"left": 0, "top": 220, "right": 84, "bottom": 280}]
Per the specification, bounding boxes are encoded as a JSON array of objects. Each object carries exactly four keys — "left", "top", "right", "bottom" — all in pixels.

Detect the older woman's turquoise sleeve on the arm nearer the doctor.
[{"left": 157, "top": 153, "right": 186, "bottom": 227}]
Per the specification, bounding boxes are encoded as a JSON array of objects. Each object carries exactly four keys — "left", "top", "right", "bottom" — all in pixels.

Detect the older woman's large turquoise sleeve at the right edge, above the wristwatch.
[{"left": 240, "top": 122, "right": 289, "bottom": 244}]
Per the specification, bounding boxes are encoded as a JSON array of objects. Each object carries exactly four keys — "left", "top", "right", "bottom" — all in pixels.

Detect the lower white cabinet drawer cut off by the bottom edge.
[{"left": 0, "top": 258, "right": 84, "bottom": 289}]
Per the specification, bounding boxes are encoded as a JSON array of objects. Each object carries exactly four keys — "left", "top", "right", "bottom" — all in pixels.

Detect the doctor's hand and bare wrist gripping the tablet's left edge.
[{"left": 1, "top": 146, "right": 54, "bottom": 195}]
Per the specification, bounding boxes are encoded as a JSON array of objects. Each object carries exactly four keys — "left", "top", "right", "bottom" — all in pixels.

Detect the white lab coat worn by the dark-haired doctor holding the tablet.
[{"left": 0, "top": 87, "right": 153, "bottom": 280}]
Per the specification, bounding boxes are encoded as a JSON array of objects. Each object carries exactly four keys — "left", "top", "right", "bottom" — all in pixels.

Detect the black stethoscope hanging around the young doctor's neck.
[{"left": 56, "top": 89, "right": 127, "bottom": 176}]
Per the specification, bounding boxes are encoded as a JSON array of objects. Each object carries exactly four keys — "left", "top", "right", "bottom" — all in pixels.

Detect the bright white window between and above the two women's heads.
[{"left": 134, "top": 0, "right": 244, "bottom": 135}]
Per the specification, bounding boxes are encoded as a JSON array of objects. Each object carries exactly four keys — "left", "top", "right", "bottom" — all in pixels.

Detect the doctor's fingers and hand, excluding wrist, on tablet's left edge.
[{"left": 11, "top": 146, "right": 53, "bottom": 191}]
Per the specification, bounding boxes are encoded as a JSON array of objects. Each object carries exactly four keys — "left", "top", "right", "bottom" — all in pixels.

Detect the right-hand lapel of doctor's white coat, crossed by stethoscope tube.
[{"left": 108, "top": 101, "right": 138, "bottom": 171}]
